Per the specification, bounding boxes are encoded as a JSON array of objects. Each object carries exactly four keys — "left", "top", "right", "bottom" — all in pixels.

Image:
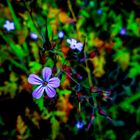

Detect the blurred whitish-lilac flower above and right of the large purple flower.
[{"left": 67, "top": 38, "right": 83, "bottom": 52}]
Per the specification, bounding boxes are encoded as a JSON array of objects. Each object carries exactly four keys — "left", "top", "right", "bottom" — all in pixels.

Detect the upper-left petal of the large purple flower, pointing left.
[{"left": 28, "top": 74, "right": 43, "bottom": 85}]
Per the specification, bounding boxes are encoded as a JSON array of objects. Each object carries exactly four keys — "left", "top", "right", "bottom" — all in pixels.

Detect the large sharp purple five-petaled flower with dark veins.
[{"left": 28, "top": 67, "right": 60, "bottom": 99}]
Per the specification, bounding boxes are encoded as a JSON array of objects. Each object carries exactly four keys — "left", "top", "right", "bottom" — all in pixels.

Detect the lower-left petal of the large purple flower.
[{"left": 32, "top": 85, "right": 44, "bottom": 99}]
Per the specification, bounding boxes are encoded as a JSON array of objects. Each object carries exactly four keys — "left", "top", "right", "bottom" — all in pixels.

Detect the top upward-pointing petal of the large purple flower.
[{"left": 42, "top": 67, "right": 52, "bottom": 82}]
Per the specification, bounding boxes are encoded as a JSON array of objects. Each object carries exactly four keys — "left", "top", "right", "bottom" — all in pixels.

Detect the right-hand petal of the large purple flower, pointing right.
[{"left": 48, "top": 77, "right": 60, "bottom": 88}]
